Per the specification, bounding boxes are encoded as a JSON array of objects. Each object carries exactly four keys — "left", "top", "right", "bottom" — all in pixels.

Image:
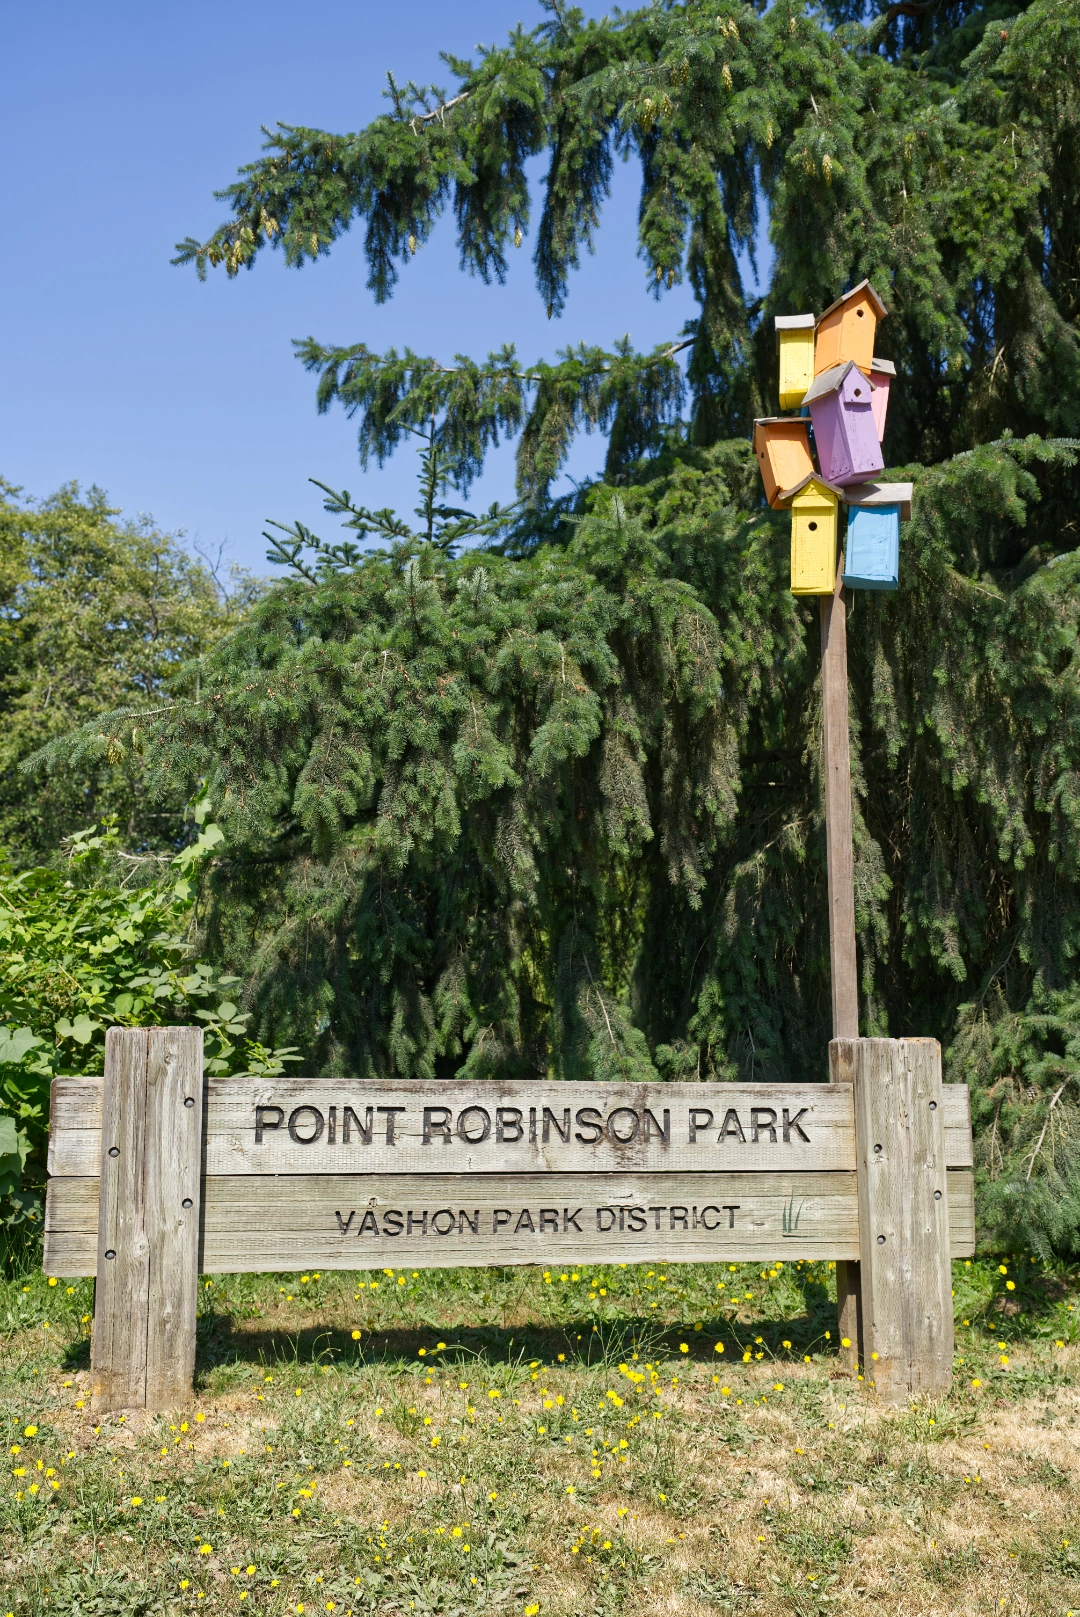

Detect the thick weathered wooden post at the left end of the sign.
[{"left": 91, "top": 1027, "right": 204, "bottom": 1412}]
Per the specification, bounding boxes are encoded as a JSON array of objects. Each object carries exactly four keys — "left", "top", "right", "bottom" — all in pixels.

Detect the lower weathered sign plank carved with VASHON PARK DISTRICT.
[{"left": 45, "top": 1169, "right": 975, "bottom": 1277}]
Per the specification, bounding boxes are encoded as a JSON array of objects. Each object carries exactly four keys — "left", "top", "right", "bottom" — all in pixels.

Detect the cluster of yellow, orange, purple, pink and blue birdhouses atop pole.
[{"left": 753, "top": 281, "right": 912, "bottom": 595}]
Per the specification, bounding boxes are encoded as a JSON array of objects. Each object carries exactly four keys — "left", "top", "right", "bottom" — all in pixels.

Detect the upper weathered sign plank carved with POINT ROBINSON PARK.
[{"left": 49, "top": 1077, "right": 972, "bottom": 1177}]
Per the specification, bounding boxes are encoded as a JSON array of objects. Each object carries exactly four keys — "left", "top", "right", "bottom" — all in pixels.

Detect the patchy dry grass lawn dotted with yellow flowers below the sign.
[{"left": 0, "top": 1263, "right": 1080, "bottom": 1617}]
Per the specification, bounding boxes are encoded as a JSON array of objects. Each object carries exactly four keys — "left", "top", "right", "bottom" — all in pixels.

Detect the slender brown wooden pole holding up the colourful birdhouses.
[{"left": 820, "top": 555, "right": 863, "bottom": 1368}]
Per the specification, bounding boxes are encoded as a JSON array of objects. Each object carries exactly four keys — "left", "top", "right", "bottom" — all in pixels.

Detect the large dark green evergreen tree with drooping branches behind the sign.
[{"left": 37, "top": 0, "right": 1080, "bottom": 1250}]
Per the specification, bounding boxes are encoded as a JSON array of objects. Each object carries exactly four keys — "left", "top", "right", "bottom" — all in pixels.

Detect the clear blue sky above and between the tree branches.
[{"left": 0, "top": 0, "right": 759, "bottom": 572}]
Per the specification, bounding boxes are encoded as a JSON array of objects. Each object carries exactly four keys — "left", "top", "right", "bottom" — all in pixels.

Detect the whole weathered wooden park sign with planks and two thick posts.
[{"left": 44, "top": 1028, "right": 975, "bottom": 1410}]
